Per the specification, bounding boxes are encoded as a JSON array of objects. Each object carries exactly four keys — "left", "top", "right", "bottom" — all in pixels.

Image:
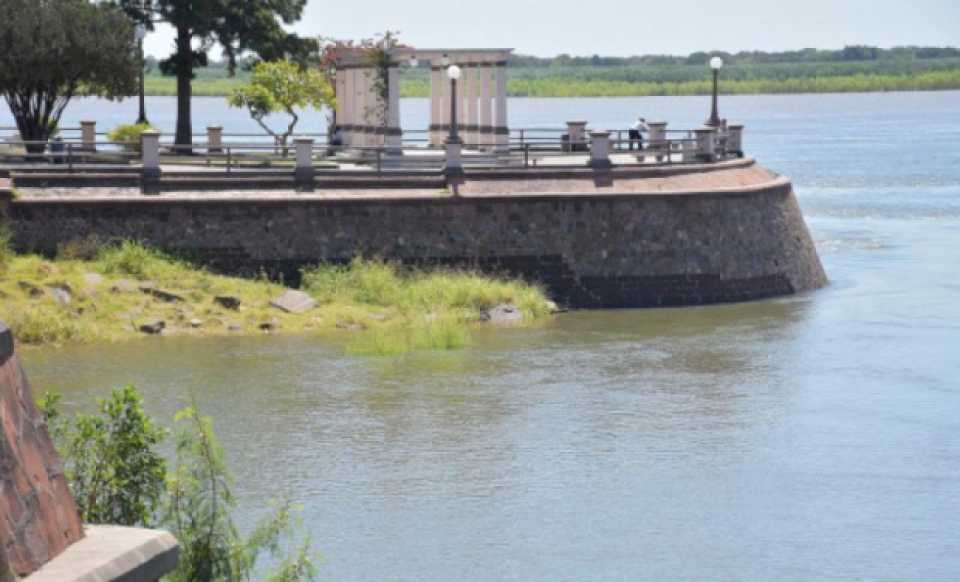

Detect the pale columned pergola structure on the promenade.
[{"left": 336, "top": 48, "right": 512, "bottom": 153}]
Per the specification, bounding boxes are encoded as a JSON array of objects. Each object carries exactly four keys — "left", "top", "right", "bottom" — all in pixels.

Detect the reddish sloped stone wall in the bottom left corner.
[{"left": 0, "top": 324, "right": 83, "bottom": 580}]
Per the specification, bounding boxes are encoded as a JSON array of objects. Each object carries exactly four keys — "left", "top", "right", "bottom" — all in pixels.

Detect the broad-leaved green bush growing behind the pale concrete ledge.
[{"left": 44, "top": 386, "right": 166, "bottom": 527}]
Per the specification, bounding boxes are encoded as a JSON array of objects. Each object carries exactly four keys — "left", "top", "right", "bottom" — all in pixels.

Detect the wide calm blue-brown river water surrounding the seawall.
[{"left": 13, "top": 92, "right": 960, "bottom": 581}]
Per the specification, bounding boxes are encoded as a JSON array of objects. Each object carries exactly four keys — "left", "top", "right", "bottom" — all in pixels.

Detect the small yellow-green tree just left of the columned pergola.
[{"left": 227, "top": 60, "right": 334, "bottom": 155}]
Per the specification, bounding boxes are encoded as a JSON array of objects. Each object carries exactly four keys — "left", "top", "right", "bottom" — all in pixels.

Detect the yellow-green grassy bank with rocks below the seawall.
[{"left": 0, "top": 241, "right": 550, "bottom": 356}]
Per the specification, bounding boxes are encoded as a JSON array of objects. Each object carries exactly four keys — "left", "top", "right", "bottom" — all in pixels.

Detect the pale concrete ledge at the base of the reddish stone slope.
[{"left": 24, "top": 525, "right": 180, "bottom": 582}]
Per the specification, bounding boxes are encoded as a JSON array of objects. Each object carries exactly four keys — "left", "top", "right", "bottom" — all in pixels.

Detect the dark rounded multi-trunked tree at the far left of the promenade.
[{"left": 0, "top": 0, "right": 140, "bottom": 153}]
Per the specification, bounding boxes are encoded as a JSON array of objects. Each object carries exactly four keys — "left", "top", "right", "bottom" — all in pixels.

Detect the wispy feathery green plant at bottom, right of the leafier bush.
[{"left": 166, "top": 407, "right": 317, "bottom": 582}]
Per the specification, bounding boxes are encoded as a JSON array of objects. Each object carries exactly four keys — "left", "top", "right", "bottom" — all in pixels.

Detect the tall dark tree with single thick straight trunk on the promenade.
[{"left": 111, "top": 0, "right": 316, "bottom": 150}]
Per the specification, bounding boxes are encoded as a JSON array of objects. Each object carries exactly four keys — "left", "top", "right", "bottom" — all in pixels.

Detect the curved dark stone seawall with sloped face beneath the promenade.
[{"left": 9, "top": 163, "right": 826, "bottom": 308}]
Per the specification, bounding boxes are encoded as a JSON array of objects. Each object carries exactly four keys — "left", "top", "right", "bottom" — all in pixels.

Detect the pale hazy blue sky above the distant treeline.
[{"left": 139, "top": 0, "right": 960, "bottom": 57}]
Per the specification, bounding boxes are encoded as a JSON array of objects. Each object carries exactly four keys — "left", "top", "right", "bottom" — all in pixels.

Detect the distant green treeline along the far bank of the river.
[{"left": 141, "top": 46, "right": 960, "bottom": 97}]
